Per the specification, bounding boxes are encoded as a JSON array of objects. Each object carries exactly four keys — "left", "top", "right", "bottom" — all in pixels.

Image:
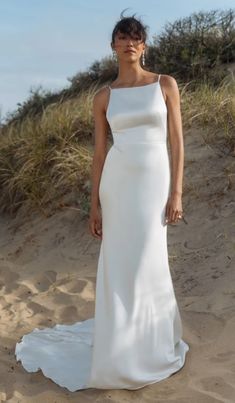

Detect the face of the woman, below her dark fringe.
[{"left": 111, "top": 32, "right": 145, "bottom": 61}]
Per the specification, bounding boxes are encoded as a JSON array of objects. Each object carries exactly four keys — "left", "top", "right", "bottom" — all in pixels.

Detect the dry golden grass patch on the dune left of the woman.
[{"left": 0, "top": 87, "right": 97, "bottom": 213}]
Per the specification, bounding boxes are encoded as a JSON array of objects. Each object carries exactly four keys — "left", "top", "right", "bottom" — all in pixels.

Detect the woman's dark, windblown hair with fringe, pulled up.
[{"left": 112, "top": 8, "right": 148, "bottom": 43}]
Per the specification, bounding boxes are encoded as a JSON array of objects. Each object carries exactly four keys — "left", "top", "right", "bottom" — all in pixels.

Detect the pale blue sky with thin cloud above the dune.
[{"left": 0, "top": 0, "right": 234, "bottom": 122}]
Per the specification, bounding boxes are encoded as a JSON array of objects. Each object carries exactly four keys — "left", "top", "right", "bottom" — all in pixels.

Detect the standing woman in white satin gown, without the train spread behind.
[{"left": 86, "top": 11, "right": 189, "bottom": 389}]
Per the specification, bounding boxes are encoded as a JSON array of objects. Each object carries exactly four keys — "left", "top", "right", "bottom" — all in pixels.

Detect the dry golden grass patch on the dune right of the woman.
[{"left": 181, "top": 76, "right": 235, "bottom": 154}]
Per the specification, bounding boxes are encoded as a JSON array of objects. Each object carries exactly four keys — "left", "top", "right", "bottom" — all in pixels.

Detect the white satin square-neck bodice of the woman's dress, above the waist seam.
[{"left": 106, "top": 75, "right": 167, "bottom": 143}]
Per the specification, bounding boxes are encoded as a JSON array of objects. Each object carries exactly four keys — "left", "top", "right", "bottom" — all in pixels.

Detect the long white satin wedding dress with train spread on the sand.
[{"left": 15, "top": 76, "right": 189, "bottom": 392}]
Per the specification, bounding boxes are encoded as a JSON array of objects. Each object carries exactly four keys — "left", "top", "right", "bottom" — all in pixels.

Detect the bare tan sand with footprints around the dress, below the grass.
[{"left": 0, "top": 130, "right": 235, "bottom": 403}]
